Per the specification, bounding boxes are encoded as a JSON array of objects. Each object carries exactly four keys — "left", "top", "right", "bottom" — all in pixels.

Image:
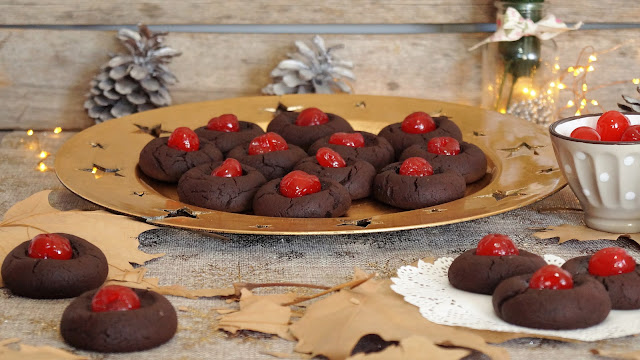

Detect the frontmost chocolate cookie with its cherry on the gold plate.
[{"left": 253, "top": 170, "right": 351, "bottom": 218}]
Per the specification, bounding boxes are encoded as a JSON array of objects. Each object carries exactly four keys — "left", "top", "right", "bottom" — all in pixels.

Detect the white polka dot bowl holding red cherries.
[{"left": 549, "top": 113, "right": 640, "bottom": 233}]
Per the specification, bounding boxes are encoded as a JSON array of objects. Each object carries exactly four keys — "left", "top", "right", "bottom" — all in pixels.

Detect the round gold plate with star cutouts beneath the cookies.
[{"left": 55, "top": 94, "right": 566, "bottom": 235}]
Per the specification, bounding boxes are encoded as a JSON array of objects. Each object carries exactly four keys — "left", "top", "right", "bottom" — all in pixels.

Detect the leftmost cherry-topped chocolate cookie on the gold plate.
[{"left": 138, "top": 127, "right": 224, "bottom": 183}]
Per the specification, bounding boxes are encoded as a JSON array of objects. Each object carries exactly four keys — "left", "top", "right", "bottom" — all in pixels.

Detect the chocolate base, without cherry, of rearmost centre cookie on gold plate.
[{"left": 267, "top": 111, "right": 353, "bottom": 151}]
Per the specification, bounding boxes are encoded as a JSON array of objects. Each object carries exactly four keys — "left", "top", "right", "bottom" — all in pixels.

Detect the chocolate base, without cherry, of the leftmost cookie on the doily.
[{"left": 448, "top": 249, "right": 547, "bottom": 295}]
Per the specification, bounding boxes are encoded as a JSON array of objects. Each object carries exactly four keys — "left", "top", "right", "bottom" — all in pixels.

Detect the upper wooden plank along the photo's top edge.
[{"left": 0, "top": 0, "right": 640, "bottom": 25}]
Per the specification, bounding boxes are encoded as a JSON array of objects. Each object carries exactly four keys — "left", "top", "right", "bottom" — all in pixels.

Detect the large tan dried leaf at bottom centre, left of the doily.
[{"left": 290, "top": 274, "right": 508, "bottom": 359}]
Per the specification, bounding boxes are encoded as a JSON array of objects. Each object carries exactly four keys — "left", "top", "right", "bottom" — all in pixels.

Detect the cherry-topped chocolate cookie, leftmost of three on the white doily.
[{"left": 447, "top": 234, "right": 547, "bottom": 295}]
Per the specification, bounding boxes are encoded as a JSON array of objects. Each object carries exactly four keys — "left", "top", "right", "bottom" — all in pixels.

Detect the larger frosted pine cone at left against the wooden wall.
[{"left": 84, "top": 24, "right": 181, "bottom": 123}]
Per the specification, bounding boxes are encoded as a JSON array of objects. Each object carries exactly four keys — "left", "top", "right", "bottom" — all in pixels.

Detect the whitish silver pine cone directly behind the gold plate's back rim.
[{"left": 262, "top": 35, "right": 355, "bottom": 95}]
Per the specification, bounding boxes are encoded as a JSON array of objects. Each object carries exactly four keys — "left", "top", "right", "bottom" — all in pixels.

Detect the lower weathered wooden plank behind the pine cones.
[{"left": 0, "top": 29, "right": 640, "bottom": 129}]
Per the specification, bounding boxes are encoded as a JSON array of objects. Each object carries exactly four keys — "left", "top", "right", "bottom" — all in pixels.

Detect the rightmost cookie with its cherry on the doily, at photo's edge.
[{"left": 562, "top": 247, "right": 640, "bottom": 310}]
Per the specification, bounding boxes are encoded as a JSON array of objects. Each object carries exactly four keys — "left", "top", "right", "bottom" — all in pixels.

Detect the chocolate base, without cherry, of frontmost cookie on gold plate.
[{"left": 253, "top": 178, "right": 351, "bottom": 218}]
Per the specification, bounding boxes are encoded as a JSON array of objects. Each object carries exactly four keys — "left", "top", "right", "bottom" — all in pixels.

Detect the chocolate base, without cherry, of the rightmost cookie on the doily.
[{"left": 562, "top": 255, "right": 640, "bottom": 310}]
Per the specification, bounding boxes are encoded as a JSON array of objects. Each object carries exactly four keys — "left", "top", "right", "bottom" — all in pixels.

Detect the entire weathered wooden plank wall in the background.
[{"left": 0, "top": 0, "right": 640, "bottom": 129}]
